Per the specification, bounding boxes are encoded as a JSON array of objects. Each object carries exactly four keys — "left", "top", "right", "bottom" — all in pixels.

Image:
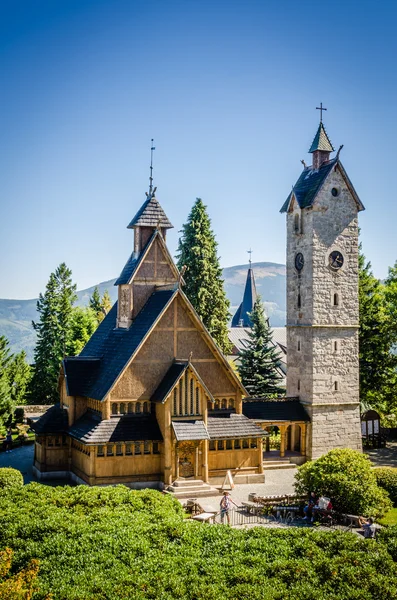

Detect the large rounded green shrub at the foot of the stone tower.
[{"left": 295, "top": 448, "right": 391, "bottom": 516}]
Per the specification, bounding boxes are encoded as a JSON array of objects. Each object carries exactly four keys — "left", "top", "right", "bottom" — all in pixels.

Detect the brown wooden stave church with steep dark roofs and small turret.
[{"left": 34, "top": 189, "right": 270, "bottom": 489}]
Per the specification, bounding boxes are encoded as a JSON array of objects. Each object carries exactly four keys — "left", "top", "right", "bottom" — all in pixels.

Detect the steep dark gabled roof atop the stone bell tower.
[{"left": 280, "top": 156, "right": 364, "bottom": 213}]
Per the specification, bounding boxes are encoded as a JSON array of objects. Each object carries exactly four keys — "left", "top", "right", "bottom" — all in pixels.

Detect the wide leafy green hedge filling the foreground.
[{"left": 0, "top": 483, "right": 397, "bottom": 600}]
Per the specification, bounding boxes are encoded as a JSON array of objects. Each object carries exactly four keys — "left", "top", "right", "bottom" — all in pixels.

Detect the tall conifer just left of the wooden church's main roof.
[{"left": 30, "top": 263, "right": 76, "bottom": 404}]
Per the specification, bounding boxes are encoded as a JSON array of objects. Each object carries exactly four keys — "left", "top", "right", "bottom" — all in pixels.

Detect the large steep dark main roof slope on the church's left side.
[{"left": 66, "top": 290, "right": 177, "bottom": 400}]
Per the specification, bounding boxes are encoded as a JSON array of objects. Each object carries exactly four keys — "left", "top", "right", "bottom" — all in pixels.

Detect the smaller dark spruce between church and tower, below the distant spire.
[{"left": 238, "top": 296, "right": 285, "bottom": 398}]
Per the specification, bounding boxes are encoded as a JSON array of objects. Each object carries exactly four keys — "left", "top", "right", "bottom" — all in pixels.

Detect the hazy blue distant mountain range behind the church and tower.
[{"left": 0, "top": 262, "right": 286, "bottom": 362}]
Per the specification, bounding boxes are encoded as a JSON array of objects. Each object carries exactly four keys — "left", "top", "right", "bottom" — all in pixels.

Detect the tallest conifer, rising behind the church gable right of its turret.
[{"left": 177, "top": 198, "right": 231, "bottom": 354}]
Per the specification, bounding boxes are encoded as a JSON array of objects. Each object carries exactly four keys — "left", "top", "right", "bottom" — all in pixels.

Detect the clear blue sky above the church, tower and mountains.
[{"left": 0, "top": 0, "right": 397, "bottom": 298}]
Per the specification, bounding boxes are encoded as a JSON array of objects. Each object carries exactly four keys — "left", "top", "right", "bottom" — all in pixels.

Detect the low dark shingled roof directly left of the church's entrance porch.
[{"left": 68, "top": 411, "right": 163, "bottom": 444}]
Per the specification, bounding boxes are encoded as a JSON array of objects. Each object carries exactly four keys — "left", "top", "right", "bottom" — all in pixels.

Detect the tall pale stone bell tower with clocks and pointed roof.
[{"left": 281, "top": 109, "right": 364, "bottom": 459}]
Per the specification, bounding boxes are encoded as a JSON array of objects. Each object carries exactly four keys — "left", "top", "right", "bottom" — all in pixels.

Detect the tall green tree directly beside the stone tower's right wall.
[{"left": 359, "top": 247, "right": 397, "bottom": 414}]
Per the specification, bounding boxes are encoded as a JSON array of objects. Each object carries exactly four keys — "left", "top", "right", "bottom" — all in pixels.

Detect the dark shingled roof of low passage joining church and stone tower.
[{"left": 243, "top": 399, "right": 310, "bottom": 422}]
